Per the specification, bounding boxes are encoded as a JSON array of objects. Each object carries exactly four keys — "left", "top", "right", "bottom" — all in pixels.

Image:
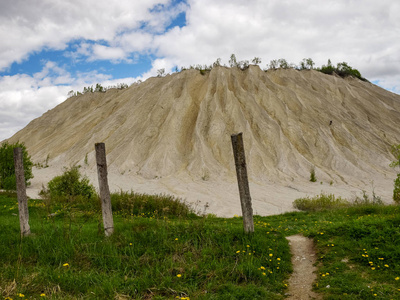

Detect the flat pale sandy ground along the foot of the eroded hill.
[{"left": 27, "top": 167, "right": 393, "bottom": 217}]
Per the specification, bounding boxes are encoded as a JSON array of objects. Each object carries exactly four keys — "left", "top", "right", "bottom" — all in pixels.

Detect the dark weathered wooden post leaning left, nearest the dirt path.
[{"left": 231, "top": 133, "right": 254, "bottom": 233}]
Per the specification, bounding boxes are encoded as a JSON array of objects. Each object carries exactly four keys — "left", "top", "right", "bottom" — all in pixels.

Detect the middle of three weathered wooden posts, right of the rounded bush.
[{"left": 95, "top": 143, "right": 114, "bottom": 236}]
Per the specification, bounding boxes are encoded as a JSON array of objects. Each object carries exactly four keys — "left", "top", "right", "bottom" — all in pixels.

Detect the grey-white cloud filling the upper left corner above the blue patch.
[{"left": 0, "top": 0, "right": 172, "bottom": 71}]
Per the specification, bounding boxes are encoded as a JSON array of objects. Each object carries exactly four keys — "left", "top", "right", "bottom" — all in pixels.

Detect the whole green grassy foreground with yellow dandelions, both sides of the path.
[{"left": 0, "top": 194, "right": 400, "bottom": 299}]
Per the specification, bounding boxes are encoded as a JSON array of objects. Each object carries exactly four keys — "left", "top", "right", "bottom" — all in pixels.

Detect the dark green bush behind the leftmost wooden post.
[{"left": 0, "top": 142, "right": 33, "bottom": 190}]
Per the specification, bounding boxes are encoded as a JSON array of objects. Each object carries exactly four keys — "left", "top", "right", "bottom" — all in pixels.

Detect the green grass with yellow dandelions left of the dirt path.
[{"left": 0, "top": 193, "right": 291, "bottom": 299}]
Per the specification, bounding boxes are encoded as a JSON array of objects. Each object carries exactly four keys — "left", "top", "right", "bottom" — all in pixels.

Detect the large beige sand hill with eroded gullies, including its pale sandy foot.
[{"left": 5, "top": 66, "right": 400, "bottom": 216}]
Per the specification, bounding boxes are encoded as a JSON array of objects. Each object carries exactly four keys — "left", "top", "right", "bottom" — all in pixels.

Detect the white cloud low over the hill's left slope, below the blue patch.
[{"left": 0, "top": 62, "right": 141, "bottom": 141}]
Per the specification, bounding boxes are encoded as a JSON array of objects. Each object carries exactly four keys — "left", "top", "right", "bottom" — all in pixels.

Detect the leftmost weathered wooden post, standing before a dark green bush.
[{"left": 14, "top": 147, "right": 31, "bottom": 236}]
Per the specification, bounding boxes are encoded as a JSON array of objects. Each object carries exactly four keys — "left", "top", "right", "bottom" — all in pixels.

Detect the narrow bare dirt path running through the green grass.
[{"left": 286, "top": 234, "right": 322, "bottom": 300}]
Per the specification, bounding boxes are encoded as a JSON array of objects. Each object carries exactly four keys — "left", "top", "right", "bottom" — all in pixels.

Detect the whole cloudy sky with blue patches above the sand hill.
[{"left": 0, "top": 0, "right": 400, "bottom": 141}]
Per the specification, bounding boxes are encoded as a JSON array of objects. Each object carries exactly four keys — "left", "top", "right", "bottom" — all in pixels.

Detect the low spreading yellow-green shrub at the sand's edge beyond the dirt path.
[{"left": 293, "top": 194, "right": 350, "bottom": 211}]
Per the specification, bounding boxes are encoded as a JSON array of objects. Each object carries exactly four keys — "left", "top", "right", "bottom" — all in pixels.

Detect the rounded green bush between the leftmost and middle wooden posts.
[{"left": 40, "top": 166, "right": 96, "bottom": 202}]
